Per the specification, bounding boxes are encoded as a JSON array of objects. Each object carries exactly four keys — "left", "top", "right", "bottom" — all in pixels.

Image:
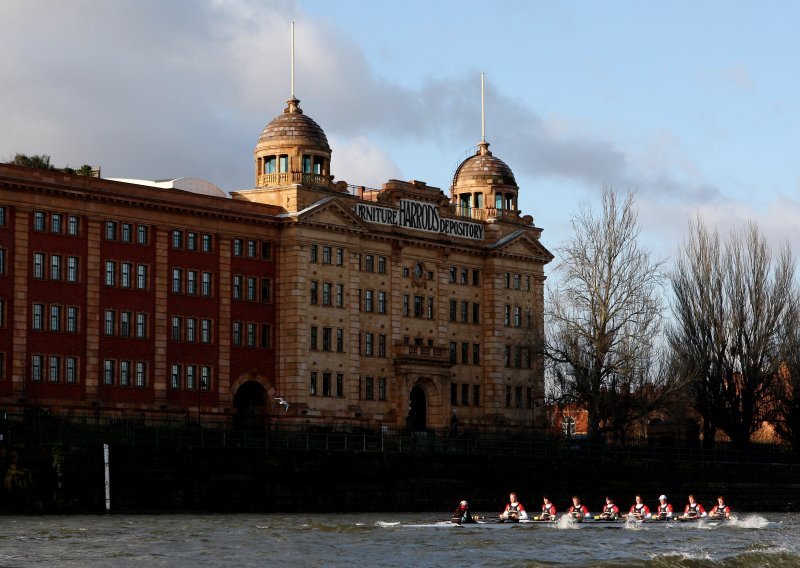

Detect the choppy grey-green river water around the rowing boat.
[{"left": 0, "top": 513, "right": 800, "bottom": 568}]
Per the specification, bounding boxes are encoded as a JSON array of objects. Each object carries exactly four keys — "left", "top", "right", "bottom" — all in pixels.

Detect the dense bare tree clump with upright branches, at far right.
[{"left": 668, "top": 219, "right": 795, "bottom": 447}]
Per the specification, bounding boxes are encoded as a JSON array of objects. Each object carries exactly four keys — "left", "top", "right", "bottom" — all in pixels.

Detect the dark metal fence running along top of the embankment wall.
[{"left": 0, "top": 413, "right": 800, "bottom": 464}]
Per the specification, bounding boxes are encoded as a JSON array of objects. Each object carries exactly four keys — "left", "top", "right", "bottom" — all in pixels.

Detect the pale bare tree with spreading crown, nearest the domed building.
[{"left": 545, "top": 187, "right": 666, "bottom": 440}]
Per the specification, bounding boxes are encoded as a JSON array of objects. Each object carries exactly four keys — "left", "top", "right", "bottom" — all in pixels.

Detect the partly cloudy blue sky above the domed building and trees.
[{"left": 0, "top": 0, "right": 800, "bottom": 258}]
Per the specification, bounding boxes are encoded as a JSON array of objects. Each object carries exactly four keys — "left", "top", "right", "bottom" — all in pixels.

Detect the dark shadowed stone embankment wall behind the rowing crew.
[{"left": 0, "top": 445, "right": 800, "bottom": 515}]
